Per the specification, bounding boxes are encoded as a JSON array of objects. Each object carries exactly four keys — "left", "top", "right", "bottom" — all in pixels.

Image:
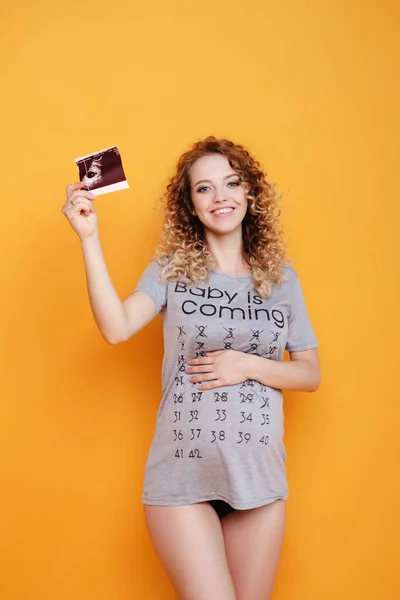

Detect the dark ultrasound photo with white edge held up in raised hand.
[{"left": 75, "top": 146, "right": 129, "bottom": 196}]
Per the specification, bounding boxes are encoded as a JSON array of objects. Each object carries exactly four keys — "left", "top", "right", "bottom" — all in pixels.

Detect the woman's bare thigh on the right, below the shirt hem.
[{"left": 221, "top": 500, "right": 286, "bottom": 600}]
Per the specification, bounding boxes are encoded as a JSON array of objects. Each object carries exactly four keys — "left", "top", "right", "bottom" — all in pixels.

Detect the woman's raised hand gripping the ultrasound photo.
[{"left": 61, "top": 181, "right": 98, "bottom": 241}]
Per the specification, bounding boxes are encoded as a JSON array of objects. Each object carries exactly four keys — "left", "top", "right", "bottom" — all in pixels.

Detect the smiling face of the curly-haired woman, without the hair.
[{"left": 190, "top": 154, "right": 247, "bottom": 235}]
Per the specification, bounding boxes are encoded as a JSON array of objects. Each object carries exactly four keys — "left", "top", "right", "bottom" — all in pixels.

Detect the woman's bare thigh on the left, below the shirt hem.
[{"left": 145, "top": 502, "right": 236, "bottom": 600}]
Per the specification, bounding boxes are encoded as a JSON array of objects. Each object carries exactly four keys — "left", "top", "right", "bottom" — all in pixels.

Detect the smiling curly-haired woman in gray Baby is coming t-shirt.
[{"left": 63, "top": 137, "right": 320, "bottom": 600}]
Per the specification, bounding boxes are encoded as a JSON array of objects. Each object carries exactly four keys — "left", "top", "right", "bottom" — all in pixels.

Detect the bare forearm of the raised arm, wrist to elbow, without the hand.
[{"left": 81, "top": 234, "right": 127, "bottom": 344}]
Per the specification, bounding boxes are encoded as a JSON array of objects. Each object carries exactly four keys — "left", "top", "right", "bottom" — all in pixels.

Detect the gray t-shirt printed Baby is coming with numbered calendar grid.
[{"left": 135, "top": 261, "right": 319, "bottom": 509}]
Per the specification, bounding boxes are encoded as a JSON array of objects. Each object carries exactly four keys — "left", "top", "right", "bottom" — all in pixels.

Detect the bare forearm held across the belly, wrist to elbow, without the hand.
[{"left": 247, "top": 355, "right": 320, "bottom": 392}]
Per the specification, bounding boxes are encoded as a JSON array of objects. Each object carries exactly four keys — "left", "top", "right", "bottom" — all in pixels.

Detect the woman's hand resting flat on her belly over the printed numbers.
[{"left": 186, "top": 350, "right": 252, "bottom": 390}]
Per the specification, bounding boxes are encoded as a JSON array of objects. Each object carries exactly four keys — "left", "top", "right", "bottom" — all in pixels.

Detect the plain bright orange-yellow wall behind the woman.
[{"left": 0, "top": 0, "right": 400, "bottom": 600}]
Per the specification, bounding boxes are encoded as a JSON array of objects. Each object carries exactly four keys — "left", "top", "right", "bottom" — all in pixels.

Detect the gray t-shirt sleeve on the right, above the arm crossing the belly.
[{"left": 286, "top": 267, "right": 319, "bottom": 352}]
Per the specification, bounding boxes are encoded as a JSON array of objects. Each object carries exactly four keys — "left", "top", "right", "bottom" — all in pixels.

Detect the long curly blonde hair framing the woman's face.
[{"left": 156, "top": 136, "right": 288, "bottom": 298}]
